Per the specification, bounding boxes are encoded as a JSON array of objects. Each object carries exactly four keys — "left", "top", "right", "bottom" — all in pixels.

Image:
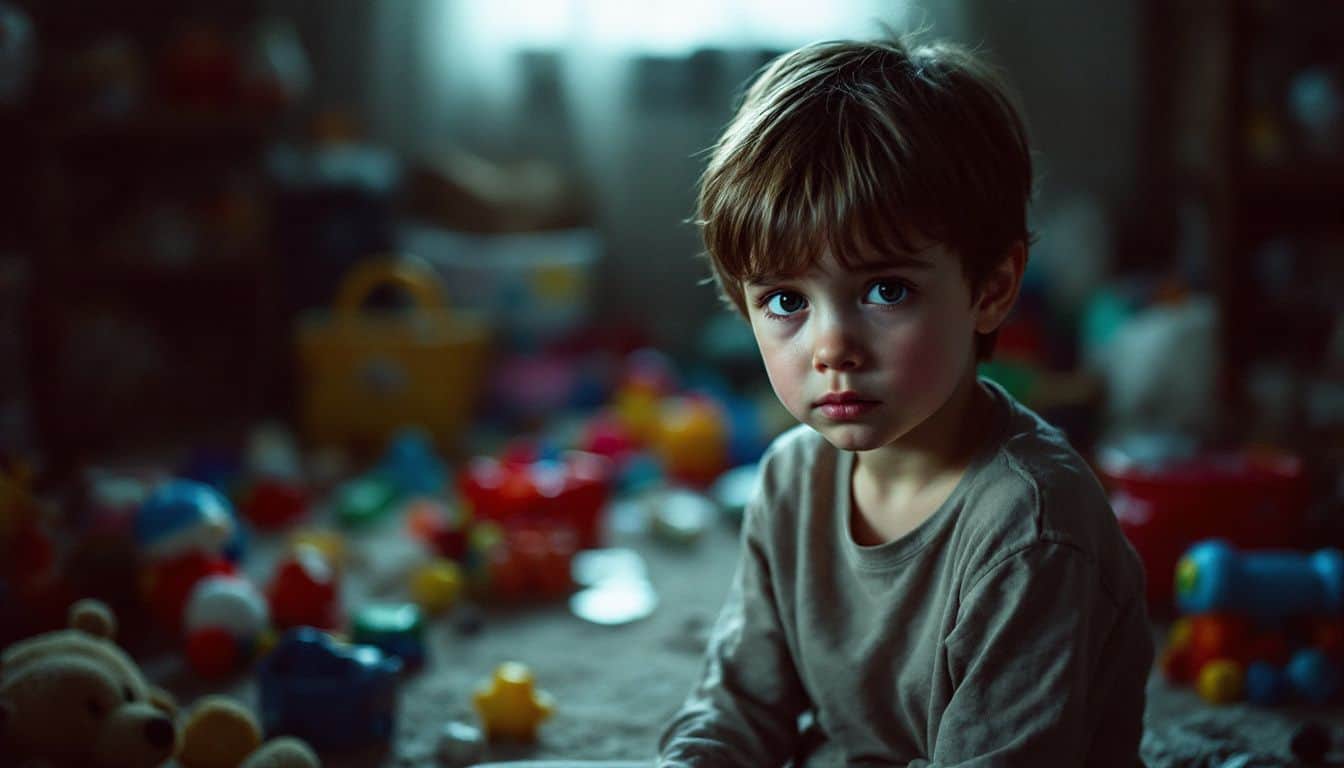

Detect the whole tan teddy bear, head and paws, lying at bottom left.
[{"left": 0, "top": 600, "right": 321, "bottom": 768}]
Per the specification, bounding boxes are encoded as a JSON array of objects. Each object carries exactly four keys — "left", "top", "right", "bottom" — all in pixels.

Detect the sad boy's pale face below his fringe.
[{"left": 745, "top": 245, "right": 982, "bottom": 451}]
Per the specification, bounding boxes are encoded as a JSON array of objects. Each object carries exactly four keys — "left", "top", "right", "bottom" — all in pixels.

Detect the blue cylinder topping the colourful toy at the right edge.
[{"left": 1176, "top": 539, "right": 1344, "bottom": 619}]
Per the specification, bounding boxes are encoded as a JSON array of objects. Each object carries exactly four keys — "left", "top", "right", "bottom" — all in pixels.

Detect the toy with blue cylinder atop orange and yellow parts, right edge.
[{"left": 1160, "top": 539, "right": 1344, "bottom": 706}]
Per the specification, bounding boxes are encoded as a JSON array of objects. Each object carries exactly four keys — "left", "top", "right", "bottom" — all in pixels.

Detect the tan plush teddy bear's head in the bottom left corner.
[{"left": 0, "top": 600, "right": 177, "bottom": 768}]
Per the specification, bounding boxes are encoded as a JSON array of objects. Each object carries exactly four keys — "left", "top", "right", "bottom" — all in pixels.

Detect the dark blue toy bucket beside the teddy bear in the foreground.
[{"left": 258, "top": 627, "right": 402, "bottom": 749}]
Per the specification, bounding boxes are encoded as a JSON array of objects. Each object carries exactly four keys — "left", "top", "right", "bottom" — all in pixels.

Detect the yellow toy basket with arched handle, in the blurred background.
[{"left": 296, "top": 258, "right": 489, "bottom": 448}]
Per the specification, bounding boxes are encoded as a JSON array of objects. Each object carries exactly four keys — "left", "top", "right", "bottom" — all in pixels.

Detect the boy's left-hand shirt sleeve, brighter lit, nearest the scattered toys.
[{"left": 657, "top": 502, "right": 808, "bottom": 768}]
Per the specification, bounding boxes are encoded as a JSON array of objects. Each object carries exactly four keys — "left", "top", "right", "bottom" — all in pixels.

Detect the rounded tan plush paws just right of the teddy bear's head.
[{"left": 177, "top": 695, "right": 321, "bottom": 768}]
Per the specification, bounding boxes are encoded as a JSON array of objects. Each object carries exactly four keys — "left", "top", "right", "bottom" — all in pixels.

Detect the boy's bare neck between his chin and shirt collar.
[{"left": 855, "top": 366, "right": 992, "bottom": 500}]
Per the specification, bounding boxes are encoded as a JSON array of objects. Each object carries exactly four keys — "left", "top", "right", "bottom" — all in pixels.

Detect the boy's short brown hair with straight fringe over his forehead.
[{"left": 696, "top": 40, "right": 1032, "bottom": 359}]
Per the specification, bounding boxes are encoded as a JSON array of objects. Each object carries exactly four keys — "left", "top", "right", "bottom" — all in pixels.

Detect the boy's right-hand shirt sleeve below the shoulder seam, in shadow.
[{"left": 910, "top": 543, "right": 1153, "bottom": 768}]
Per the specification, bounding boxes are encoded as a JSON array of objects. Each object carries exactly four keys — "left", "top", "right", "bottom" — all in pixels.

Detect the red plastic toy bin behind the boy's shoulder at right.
[{"left": 1097, "top": 451, "right": 1310, "bottom": 616}]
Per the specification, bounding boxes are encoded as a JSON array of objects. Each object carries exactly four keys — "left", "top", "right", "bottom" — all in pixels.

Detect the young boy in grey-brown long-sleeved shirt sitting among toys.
[{"left": 660, "top": 34, "right": 1153, "bottom": 768}]
